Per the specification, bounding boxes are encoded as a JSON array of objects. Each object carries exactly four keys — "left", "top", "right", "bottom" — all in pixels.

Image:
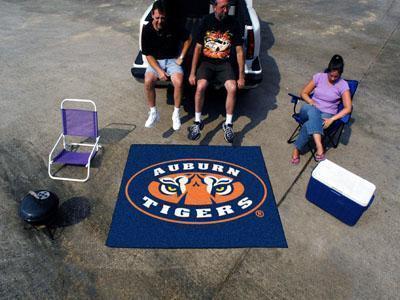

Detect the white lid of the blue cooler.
[{"left": 311, "top": 159, "right": 376, "bottom": 206}]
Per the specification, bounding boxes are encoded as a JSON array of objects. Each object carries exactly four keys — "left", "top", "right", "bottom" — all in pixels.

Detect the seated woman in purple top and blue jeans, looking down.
[{"left": 291, "top": 55, "right": 351, "bottom": 165}]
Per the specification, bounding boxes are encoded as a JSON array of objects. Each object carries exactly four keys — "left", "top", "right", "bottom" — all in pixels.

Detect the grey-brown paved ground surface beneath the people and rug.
[{"left": 0, "top": 0, "right": 400, "bottom": 299}]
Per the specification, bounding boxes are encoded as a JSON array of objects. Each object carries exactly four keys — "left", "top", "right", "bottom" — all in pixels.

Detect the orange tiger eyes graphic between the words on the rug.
[{"left": 148, "top": 172, "right": 245, "bottom": 205}]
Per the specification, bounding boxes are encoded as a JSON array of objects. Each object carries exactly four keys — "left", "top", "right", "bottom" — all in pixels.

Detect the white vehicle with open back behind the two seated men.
[{"left": 131, "top": 0, "right": 262, "bottom": 89}]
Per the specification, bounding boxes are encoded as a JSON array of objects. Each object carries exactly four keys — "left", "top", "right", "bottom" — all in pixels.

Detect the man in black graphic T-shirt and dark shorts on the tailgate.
[{"left": 188, "top": 0, "right": 244, "bottom": 143}]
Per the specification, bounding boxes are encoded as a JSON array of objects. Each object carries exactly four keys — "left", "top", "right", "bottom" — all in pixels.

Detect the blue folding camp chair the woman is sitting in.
[{"left": 287, "top": 79, "right": 358, "bottom": 159}]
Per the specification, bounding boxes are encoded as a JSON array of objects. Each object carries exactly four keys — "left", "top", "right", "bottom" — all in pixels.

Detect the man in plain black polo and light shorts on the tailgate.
[{"left": 142, "top": 1, "right": 191, "bottom": 130}]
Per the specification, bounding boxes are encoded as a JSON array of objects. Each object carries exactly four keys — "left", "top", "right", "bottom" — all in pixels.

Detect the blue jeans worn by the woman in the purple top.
[{"left": 294, "top": 104, "right": 333, "bottom": 150}]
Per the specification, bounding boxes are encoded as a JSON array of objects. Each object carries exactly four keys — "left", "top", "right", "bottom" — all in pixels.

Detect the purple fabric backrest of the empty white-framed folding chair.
[{"left": 61, "top": 108, "right": 98, "bottom": 137}]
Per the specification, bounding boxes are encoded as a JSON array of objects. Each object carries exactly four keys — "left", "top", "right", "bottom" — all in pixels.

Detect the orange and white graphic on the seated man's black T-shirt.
[{"left": 203, "top": 31, "right": 232, "bottom": 59}]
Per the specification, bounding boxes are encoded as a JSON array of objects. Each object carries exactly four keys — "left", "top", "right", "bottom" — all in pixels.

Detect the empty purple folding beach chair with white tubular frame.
[{"left": 48, "top": 99, "right": 100, "bottom": 182}]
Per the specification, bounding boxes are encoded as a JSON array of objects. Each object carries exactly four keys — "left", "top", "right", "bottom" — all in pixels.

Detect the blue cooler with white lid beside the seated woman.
[{"left": 306, "top": 159, "right": 376, "bottom": 226}]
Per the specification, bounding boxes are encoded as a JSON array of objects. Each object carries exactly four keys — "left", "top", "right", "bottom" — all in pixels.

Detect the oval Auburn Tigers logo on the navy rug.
[{"left": 125, "top": 159, "right": 267, "bottom": 224}]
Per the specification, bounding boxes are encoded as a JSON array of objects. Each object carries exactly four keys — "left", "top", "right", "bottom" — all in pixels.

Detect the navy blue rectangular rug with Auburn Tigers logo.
[{"left": 106, "top": 145, "right": 287, "bottom": 248}]
